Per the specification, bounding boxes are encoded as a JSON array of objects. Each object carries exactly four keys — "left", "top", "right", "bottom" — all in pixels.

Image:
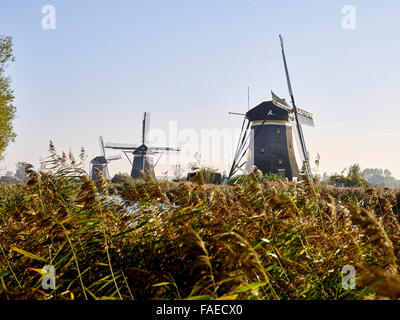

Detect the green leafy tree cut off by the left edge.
[{"left": 0, "top": 35, "right": 16, "bottom": 159}]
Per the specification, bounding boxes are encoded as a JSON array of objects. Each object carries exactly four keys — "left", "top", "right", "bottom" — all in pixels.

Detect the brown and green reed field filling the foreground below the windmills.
[{"left": 0, "top": 147, "right": 400, "bottom": 300}]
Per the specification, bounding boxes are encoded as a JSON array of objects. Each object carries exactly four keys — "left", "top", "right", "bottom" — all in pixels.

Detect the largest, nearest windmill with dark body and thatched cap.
[{"left": 229, "top": 36, "right": 314, "bottom": 180}]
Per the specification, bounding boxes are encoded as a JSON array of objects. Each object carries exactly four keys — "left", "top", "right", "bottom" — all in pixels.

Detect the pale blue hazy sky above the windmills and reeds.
[{"left": 0, "top": 0, "right": 400, "bottom": 178}]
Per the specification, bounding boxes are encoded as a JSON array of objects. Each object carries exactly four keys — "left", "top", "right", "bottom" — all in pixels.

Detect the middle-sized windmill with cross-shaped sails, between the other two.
[{"left": 104, "top": 112, "right": 181, "bottom": 179}]
